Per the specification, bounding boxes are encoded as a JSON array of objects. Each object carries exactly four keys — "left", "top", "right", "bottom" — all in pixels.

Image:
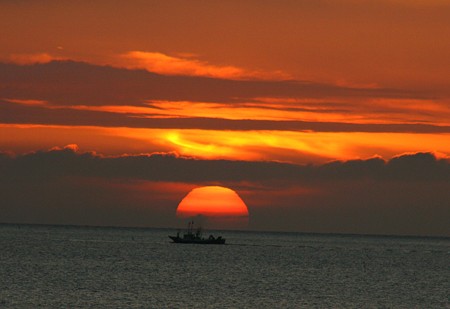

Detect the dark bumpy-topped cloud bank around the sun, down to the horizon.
[{"left": 0, "top": 147, "right": 450, "bottom": 236}]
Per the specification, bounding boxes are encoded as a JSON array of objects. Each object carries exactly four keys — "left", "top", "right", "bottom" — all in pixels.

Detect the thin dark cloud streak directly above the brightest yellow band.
[{"left": 0, "top": 100, "right": 450, "bottom": 133}]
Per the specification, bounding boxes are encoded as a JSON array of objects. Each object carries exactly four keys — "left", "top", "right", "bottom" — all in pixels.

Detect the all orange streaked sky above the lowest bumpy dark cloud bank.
[{"left": 0, "top": 0, "right": 450, "bottom": 235}]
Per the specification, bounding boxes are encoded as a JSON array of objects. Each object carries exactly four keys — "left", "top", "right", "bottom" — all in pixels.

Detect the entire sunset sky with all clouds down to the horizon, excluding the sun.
[{"left": 0, "top": 0, "right": 450, "bottom": 236}]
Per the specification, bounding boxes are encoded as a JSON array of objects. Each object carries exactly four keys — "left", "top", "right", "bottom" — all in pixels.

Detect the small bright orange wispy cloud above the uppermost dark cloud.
[{"left": 121, "top": 51, "right": 288, "bottom": 79}]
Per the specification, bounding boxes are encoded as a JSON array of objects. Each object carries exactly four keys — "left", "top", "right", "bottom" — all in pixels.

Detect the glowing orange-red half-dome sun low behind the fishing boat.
[{"left": 177, "top": 186, "right": 248, "bottom": 218}]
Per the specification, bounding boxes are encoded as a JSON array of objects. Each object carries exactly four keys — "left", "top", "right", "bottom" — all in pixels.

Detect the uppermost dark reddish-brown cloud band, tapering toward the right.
[{"left": 0, "top": 61, "right": 423, "bottom": 106}]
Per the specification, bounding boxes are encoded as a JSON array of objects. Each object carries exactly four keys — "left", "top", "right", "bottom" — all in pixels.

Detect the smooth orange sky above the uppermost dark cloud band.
[{"left": 0, "top": 0, "right": 450, "bottom": 91}]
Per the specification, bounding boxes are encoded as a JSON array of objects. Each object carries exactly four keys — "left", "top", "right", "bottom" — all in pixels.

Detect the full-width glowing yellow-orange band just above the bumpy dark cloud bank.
[{"left": 0, "top": 124, "right": 450, "bottom": 164}]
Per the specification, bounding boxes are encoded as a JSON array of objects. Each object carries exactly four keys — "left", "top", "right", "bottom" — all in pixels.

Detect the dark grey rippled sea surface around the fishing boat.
[{"left": 0, "top": 224, "right": 450, "bottom": 308}]
